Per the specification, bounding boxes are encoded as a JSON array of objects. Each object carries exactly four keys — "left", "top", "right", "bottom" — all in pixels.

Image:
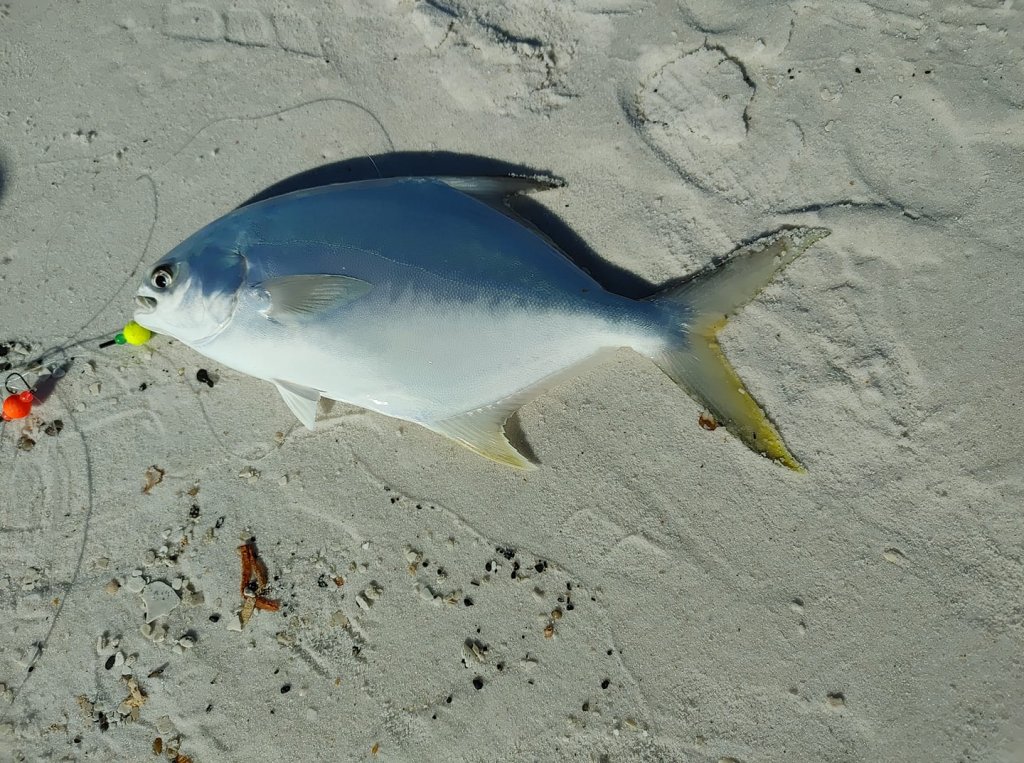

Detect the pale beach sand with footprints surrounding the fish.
[{"left": 0, "top": 0, "right": 1024, "bottom": 763}]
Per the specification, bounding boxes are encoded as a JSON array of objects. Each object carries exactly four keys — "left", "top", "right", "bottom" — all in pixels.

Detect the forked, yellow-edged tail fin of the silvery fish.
[{"left": 651, "top": 227, "right": 830, "bottom": 471}]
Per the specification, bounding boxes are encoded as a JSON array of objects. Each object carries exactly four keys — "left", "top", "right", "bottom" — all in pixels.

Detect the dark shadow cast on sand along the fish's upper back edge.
[{"left": 239, "top": 152, "right": 666, "bottom": 299}]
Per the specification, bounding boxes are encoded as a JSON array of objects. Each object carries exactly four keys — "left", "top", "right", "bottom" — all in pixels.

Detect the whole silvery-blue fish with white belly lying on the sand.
[{"left": 134, "top": 177, "right": 828, "bottom": 470}]
